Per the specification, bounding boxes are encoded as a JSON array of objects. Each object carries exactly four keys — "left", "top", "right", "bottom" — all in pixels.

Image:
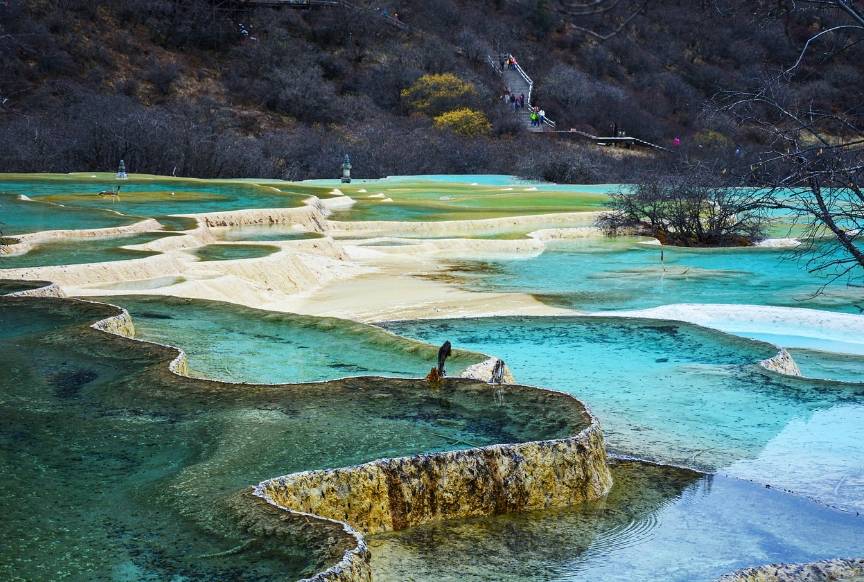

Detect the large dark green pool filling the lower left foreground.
[{"left": 0, "top": 297, "right": 560, "bottom": 580}]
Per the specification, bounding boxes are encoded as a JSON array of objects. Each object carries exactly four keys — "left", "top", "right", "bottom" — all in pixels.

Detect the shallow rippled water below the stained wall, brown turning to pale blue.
[{"left": 370, "top": 462, "right": 864, "bottom": 582}]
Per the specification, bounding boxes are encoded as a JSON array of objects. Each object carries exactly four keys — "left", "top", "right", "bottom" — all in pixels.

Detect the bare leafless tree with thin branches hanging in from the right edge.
[{"left": 715, "top": 0, "right": 864, "bottom": 278}]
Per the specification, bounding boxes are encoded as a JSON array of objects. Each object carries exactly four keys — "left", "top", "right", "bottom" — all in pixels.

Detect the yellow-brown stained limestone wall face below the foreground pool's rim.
[{"left": 255, "top": 402, "right": 612, "bottom": 533}]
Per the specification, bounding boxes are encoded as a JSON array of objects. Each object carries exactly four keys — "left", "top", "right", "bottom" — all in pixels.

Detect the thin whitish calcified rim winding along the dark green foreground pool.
[{"left": 0, "top": 281, "right": 611, "bottom": 582}]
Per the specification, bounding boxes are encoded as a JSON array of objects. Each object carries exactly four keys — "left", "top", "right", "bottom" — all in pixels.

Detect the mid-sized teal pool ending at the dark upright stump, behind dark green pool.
[{"left": 104, "top": 296, "right": 483, "bottom": 384}]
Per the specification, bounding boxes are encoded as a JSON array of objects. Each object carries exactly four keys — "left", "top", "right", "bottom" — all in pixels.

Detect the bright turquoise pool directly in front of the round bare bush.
[{"left": 453, "top": 239, "right": 864, "bottom": 313}]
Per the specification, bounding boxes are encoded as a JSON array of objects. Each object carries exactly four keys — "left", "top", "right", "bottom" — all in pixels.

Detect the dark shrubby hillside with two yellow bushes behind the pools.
[{"left": 0, "top": 0, "right": 864, "bottom": 182}]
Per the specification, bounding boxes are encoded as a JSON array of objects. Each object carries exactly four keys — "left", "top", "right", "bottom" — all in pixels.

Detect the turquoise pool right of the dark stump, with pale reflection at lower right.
[{"left": 386, "top": 317, "right": 864, "bottom": 511}]
